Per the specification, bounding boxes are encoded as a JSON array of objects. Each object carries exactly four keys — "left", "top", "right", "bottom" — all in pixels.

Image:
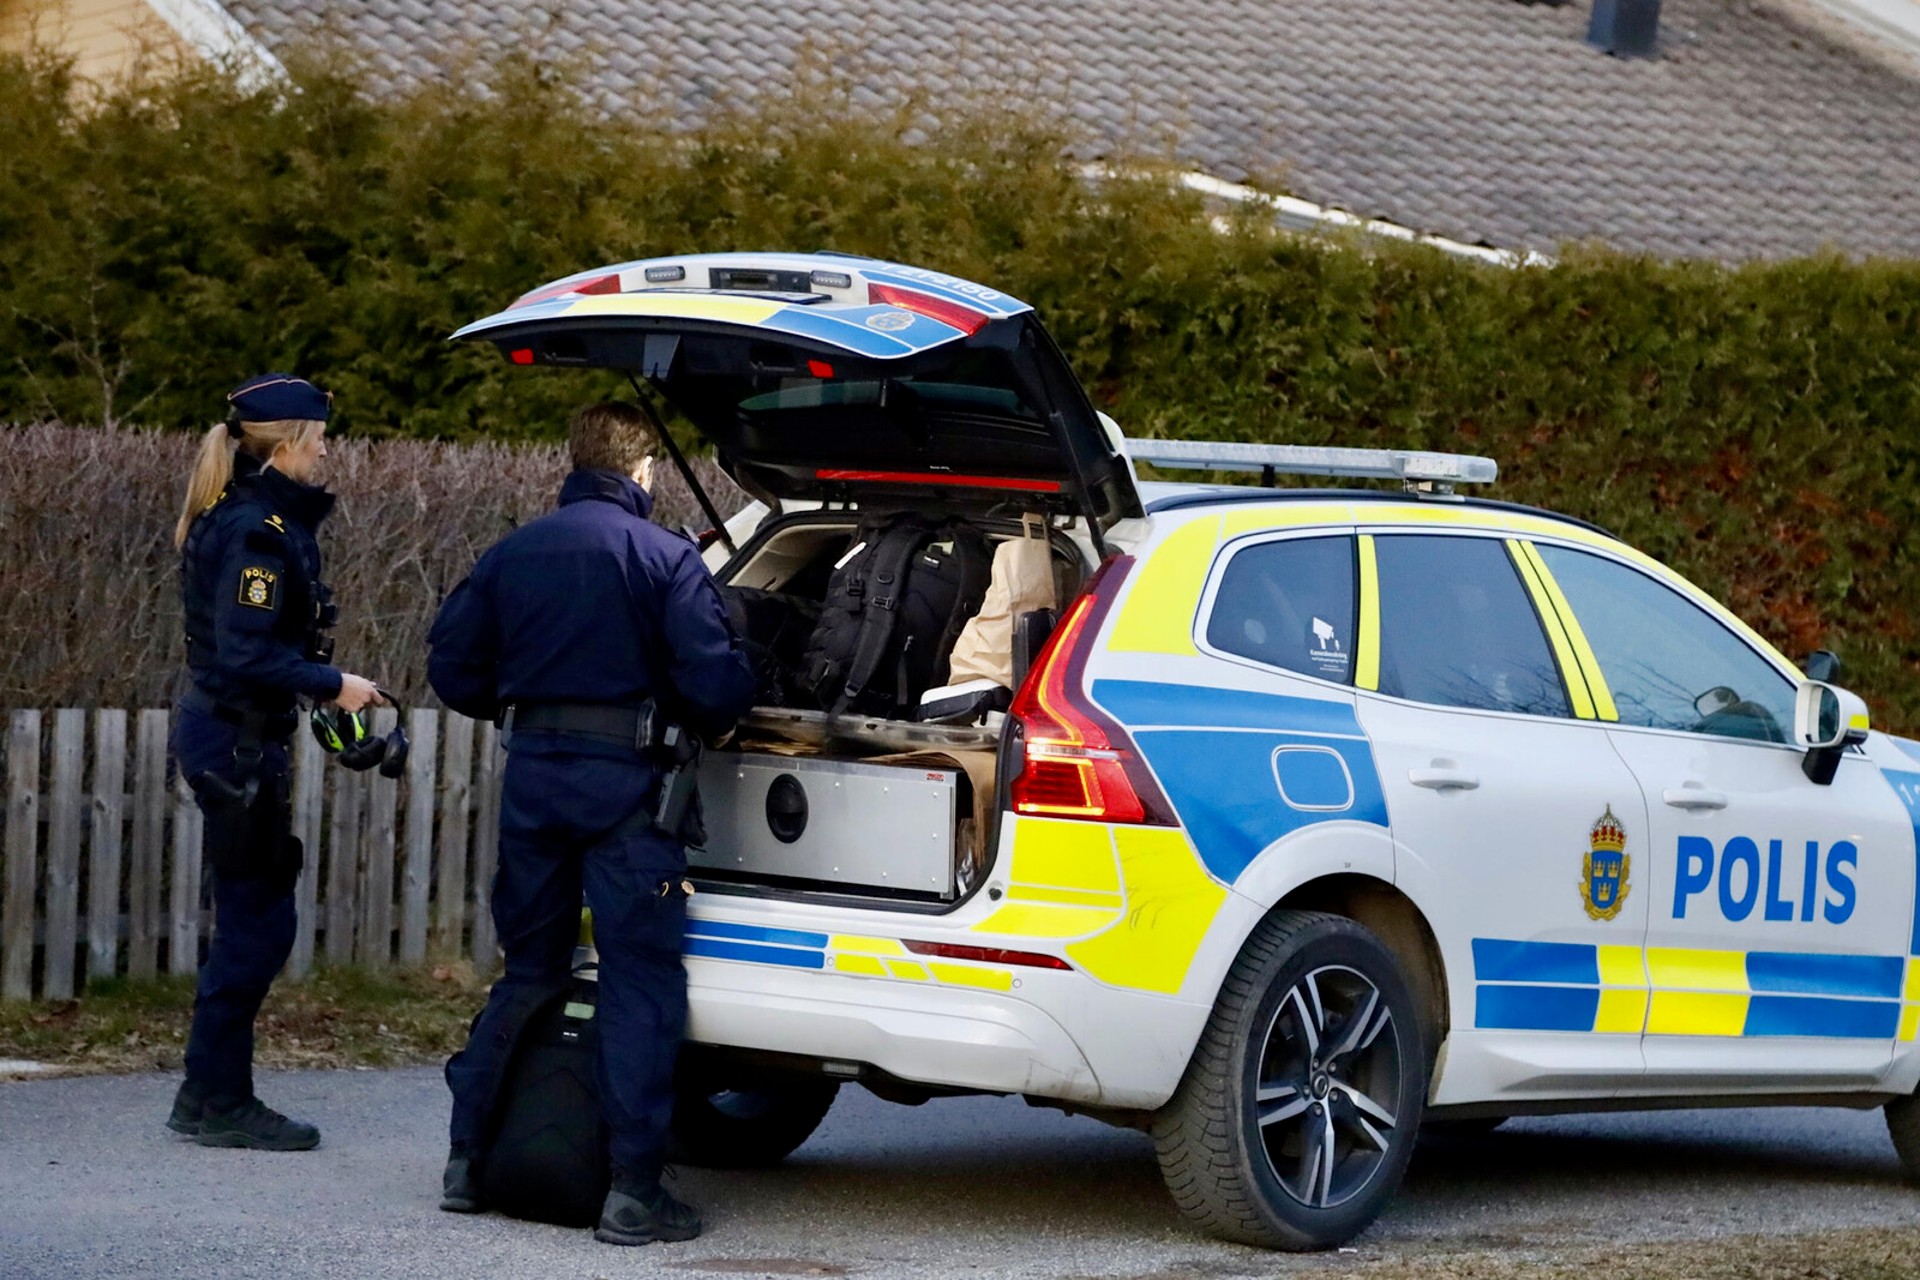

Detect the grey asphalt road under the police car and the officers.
[{"left": 0, "top": 1069, "right": 1920, "bottom": 1280}]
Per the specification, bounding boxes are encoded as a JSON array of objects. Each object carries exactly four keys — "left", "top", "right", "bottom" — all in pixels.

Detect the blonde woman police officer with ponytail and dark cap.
[{"left": 167, "top": 374, "right": 380, "bottom": 1151}]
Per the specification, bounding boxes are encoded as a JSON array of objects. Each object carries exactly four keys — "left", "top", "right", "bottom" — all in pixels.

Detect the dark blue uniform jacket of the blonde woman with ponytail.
[{"left": 180, "top": 453, "right": 340, "bottom": 712}]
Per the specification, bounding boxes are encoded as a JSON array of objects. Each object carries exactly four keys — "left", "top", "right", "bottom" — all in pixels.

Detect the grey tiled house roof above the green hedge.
[{"left": 227, "top": 0, "right": 1920, "bottom": 259}]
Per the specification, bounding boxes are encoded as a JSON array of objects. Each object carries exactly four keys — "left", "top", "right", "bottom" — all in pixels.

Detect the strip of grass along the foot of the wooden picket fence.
[{"left": 0, "top": 961, "right": 486, "bottom": 1075}]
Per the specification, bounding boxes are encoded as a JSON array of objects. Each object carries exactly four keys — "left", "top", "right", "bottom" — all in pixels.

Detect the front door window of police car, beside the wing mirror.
[{"left": 1538, "top": 545, "right": 1793, "bottom": 743}]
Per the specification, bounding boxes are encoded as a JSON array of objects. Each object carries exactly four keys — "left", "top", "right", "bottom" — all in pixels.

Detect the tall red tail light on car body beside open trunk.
[{"left": 1008, "top": 557, "right": 1173, "bottom": 825}]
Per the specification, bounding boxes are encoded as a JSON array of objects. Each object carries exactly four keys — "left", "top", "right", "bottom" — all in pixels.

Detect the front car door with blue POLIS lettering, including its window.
[{"left": 1538, "top": 541, "right": 1914, "bottom": 1094}]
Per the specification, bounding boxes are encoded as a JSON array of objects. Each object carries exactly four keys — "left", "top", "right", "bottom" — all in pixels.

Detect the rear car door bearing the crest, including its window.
[{"left": 1357, "top": 530, "right": 1649, "bottom": 1105}]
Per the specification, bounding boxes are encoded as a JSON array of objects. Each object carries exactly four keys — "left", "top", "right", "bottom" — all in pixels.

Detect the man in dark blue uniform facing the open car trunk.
[{"left": 428, "top": 403, "right": 755, "bottom": 1245}]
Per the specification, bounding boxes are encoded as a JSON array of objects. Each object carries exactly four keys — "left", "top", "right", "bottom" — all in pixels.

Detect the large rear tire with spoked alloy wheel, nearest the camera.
[{"left": 1152, "top": 912, "right": 1427, "bottom": 1251}]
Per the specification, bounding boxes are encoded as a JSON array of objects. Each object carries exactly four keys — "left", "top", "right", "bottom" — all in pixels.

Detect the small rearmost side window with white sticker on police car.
[{"left": 1206, "top": 537, "right": 1354, "bottom": 685}]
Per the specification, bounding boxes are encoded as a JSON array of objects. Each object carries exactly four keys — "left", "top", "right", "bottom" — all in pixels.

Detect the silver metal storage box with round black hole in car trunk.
[{"left": 687, "top": 752, "right": 962, "bottom": 898}]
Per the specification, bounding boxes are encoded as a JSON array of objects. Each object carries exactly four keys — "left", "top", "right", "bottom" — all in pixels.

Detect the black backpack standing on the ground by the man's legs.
[{"left": 480, "top": 977, "right": 612, "bottom": 1226}]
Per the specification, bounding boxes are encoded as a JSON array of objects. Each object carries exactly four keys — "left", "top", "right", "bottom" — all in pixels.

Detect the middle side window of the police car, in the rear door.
[{"left": 1373, "top": 535, "right": 1572, "bottom": 716}]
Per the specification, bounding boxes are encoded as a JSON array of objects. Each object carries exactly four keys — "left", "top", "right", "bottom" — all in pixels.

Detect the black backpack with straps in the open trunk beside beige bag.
[{"left": 801, "top": 514, "right": 993, "bottom": 718}]
